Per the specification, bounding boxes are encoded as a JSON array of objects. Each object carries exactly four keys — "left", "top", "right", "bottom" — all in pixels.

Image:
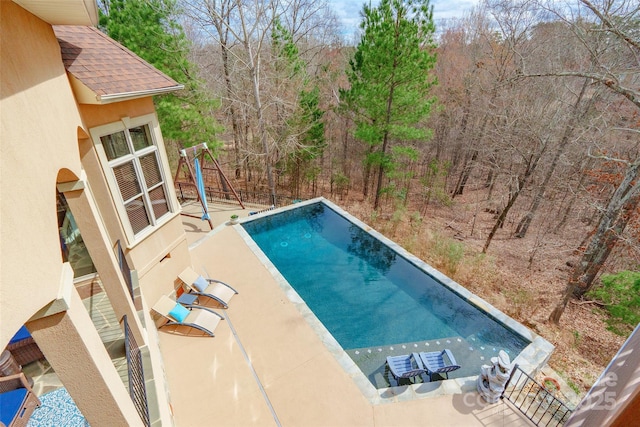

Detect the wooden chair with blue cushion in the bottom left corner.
[{"left": 0, "top": 372, "right": 40, "bottom": 427}]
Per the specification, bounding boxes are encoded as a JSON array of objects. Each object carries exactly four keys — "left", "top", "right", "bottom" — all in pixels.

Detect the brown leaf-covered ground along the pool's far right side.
[{"left": 335, "top": 193, "right": 626, "bottom": 395}]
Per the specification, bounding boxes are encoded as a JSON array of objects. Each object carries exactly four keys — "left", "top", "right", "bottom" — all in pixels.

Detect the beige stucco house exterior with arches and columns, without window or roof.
[{"left": 0, "top": 0, "right": 190, "bottom": 426}]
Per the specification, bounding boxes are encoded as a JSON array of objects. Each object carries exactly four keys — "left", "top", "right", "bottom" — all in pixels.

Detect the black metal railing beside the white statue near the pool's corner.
[{"left": 502, "top": 365, "right": 572, "bottom": 426}]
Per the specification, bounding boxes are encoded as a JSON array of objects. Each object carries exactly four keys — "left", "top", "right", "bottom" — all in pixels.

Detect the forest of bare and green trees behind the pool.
[{"left": 101, "top": 0, "right": 640, "bottom": 374}]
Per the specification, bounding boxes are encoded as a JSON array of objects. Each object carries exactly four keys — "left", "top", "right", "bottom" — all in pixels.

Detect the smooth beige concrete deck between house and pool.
[{"left": 159, "top": 200, "right": 531, "bottom": 426}]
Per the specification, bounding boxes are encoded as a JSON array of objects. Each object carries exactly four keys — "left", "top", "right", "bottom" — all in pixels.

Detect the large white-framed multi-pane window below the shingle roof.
[{"left": 92, "top": 120, "right": 171, "bottom": 236}]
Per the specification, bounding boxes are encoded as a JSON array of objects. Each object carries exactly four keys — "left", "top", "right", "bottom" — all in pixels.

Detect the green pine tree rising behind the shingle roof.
[{"left": 100, "top": 0, "right": 219, "bottom": 148}]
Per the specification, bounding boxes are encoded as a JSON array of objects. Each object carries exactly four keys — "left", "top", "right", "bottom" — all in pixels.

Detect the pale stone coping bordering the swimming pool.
[{"left": 232, "top": 197, "right": 554, "bottom": 405}]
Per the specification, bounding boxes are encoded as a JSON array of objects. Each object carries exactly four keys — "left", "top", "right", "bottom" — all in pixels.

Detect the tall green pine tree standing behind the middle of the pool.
[{"left": 341, "top": 0, "right": 436, "bottom": 209}]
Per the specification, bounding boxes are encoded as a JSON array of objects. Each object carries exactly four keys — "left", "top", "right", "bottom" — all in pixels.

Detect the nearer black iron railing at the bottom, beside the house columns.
[{"left": 122, "top": 315, "right": 151, "bottom": 427}]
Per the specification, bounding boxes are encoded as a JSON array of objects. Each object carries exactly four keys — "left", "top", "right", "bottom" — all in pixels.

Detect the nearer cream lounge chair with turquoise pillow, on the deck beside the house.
[{"left": 152, "top": 295, "right": 223, "bottom": 337}]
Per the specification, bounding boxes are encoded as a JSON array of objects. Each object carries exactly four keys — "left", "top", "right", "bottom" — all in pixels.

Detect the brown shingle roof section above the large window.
[{"left": 53, "top": 25, "right": 182, "bottom": 101}]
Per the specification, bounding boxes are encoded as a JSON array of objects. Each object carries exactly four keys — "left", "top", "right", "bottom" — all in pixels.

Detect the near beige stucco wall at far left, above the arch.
[{"left": 0, "top": 1, "right": 81, "bottom": 347}]
